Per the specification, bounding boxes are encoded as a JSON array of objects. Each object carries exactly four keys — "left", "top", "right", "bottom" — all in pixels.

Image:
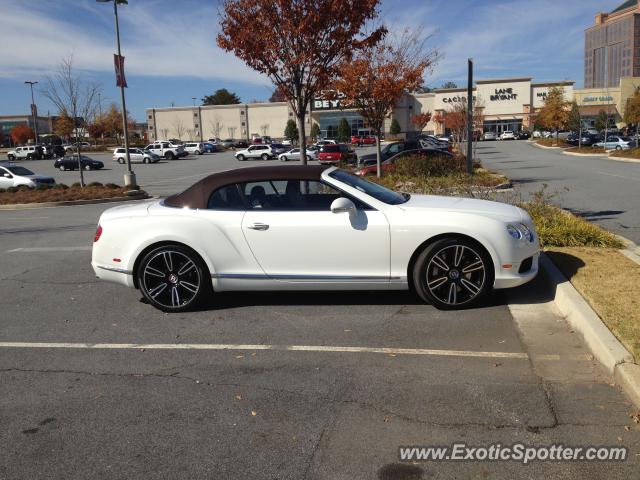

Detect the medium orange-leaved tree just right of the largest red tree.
[{"left": 334, "top": 30, "right": 437, "bottom": 177}]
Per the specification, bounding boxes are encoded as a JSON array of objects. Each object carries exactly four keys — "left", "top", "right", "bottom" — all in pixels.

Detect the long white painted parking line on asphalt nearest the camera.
[{"left": 0, "top": 342, "right": 528, "bottom": 360}]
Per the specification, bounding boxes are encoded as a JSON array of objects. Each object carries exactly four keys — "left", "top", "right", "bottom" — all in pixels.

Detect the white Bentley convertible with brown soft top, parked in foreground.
[{"left": 92, "top": 166, "right": 539, "bottom": 312}]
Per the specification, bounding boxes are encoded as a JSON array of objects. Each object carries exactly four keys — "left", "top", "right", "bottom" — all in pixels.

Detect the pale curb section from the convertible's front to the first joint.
[{"left": 540, "top": 254, "right": 634, "bottom": 376}]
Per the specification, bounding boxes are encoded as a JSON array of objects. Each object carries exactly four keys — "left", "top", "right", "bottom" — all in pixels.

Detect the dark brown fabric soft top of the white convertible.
[{"left": 164, "top": 165, "right": 330, "bottom": 208}]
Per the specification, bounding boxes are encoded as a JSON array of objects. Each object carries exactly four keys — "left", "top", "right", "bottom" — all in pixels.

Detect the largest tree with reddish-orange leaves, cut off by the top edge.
[{"left": 217, "top": 0, "right": 386, "bottom": 165}]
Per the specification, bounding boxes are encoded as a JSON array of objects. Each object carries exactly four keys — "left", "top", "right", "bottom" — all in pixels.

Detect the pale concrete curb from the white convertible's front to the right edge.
[{"left": 540, "top": 253, "right": 640, "bottom": 407}]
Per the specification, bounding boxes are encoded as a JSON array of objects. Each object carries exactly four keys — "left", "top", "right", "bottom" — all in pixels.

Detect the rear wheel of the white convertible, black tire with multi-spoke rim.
[{"left": 136, "top": 245, "right": 212, "bottom": 312}]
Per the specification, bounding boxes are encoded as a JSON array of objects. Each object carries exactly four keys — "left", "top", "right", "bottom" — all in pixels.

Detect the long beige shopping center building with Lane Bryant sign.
[{"left": 147, "top": 77, "right": 574, "bottom": 140}]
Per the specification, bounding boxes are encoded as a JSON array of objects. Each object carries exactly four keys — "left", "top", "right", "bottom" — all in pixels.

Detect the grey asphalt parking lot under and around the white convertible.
[{"left": 0, "top": 144, "right": 640, "bottom": 480}]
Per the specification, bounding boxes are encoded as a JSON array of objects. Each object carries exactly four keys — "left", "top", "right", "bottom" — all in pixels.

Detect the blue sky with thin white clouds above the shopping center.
[{"left": 0, "top": 0, "right": 622, "bottom": 120}]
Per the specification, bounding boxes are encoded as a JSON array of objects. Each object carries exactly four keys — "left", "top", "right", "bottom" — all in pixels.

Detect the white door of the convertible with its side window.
[{"left": 241, "top": 180, "right": 390, "bottom": 287}]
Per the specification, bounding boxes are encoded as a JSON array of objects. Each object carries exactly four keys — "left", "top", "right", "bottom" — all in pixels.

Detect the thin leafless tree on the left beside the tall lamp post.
[{"left": 42, "top": 55, "right": 102, "bottom": 187}]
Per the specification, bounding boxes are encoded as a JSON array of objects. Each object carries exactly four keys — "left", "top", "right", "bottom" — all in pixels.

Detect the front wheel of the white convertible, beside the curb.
[{"left": 412, "top": 238, "right": 494, "bottom": 310}]
